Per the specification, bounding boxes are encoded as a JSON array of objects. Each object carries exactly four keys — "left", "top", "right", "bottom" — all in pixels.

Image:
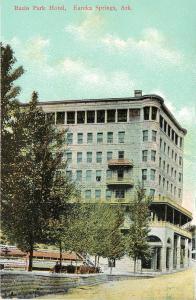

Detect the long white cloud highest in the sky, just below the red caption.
[{"left": 65, "top": 19, "right": 184, "bottom": 66}]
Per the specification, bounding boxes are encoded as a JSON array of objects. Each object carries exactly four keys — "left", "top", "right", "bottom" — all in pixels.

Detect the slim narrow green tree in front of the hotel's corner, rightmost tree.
[{"left": 127, "top": 186, "right": 151, "bottom": 272}]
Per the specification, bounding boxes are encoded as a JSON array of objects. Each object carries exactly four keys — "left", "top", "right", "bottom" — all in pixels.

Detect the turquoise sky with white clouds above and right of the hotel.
[{"left": 1, "top": 0, "right": 196, "bottom": 220}]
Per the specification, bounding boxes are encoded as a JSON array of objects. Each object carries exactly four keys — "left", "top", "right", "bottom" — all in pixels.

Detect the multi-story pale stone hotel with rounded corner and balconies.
[{"left": 40, "top": 90, "right": 191, "bottom": 271}]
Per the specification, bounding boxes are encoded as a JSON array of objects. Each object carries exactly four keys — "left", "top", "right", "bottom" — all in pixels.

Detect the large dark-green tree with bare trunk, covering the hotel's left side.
[{"left": 2, "top": 92, "right": 77, "bottom": 271}]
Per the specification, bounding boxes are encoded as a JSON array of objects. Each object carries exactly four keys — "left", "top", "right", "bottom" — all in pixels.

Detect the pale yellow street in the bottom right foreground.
[{"left": 40, "top": 268, "right": 196, "bottom": 300}]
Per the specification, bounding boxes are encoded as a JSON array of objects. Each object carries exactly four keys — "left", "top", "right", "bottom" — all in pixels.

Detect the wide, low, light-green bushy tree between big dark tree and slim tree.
[{"left": 58, "top": 203, "right": 125, "bottom": 265}]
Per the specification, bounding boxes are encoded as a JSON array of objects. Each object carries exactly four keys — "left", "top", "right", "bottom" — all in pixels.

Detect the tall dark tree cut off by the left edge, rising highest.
[{"left": 1, "top": 44, "right": 24, "bottom": 213}]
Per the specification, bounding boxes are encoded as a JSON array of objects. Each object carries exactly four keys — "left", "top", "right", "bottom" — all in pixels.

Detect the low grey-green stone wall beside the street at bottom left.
[{"left": 1, "top": 271, "right": 107, "bottom": 299}]
